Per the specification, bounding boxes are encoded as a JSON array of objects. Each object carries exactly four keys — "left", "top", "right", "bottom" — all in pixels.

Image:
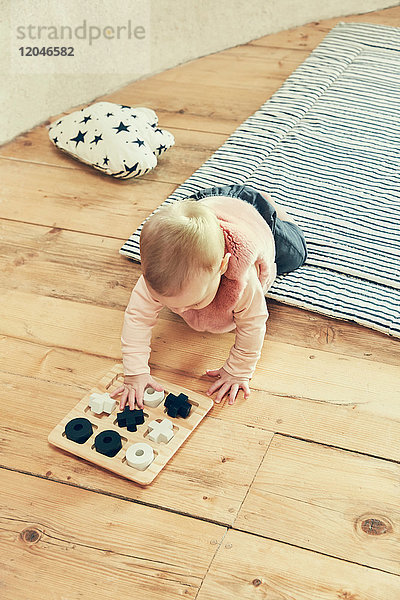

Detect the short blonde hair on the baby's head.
[{"left": 140, "top": 199, "right": 225, "bottom": 296}]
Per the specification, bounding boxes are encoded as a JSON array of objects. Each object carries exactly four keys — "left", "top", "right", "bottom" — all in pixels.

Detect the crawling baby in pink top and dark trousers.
[{"left": 111, "top": 180, "right": 307, "bottom": 409}]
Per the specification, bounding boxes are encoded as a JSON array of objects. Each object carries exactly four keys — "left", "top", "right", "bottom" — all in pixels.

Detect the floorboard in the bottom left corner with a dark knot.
[{"left": 0, "top": 469, "right": 226, "bottom": 600}]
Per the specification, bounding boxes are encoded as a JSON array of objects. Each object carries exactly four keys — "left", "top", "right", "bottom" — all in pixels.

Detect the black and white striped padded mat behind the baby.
[{"left": 120, "top": 23, "right": 400, "bottom": 336}]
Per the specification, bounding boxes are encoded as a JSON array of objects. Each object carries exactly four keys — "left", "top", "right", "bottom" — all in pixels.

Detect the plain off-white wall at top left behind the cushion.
[{"left": 0, "top": 0, "right": 398, "bottom": 144}]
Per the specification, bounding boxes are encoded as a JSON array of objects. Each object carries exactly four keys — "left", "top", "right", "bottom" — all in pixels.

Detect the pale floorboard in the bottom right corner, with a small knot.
[{"left": 197, "top": 528, "right": 400, "bottom": 600}]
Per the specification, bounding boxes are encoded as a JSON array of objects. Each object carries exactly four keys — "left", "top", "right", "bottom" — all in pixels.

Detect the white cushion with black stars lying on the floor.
[{"left": 49, "top": 102, "right": 175, "bottom": 179}]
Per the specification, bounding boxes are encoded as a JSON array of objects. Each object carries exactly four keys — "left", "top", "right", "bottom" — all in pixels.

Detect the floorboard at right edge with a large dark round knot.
[{"left": 234, "top": 435, "right": 400, "bottom": 575}]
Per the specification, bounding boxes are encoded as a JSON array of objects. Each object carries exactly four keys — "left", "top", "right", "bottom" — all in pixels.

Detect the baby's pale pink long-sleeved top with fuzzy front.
[{"left": 121, "top": 196, "right": 276, "bottom": 379}]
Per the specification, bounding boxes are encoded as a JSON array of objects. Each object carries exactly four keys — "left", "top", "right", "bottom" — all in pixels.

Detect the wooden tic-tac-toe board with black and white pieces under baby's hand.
[{"left": 48, "top": 364, "right": 213, "bottom": 485}]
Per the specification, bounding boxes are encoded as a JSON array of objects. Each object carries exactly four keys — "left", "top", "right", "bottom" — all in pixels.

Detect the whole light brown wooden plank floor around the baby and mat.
[{"left": 0, "top": 7, "right": 400, "bottom": 600}]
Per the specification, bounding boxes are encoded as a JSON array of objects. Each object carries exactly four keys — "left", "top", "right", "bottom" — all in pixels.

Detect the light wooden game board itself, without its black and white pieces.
[{"left": 48, "top": 364, "right": 213, "bottom": 485}]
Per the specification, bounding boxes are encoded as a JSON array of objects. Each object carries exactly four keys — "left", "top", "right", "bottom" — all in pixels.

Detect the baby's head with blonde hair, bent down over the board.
[{"left": 140, "top": 199, "right": 230, "bottom": 311}]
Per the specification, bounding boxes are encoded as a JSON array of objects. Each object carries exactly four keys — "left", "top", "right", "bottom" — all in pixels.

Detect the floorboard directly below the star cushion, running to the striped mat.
[{"left": 0, "top": 159, "right": 175, "bottom": 236}]
